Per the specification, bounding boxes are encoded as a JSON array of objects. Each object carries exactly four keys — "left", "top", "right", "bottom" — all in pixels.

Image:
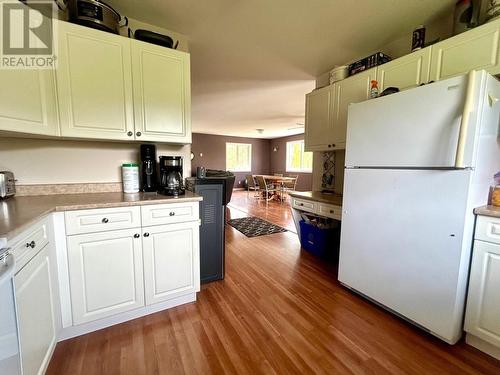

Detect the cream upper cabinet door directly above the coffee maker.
[{"left": 132, "top": 40, "right": 191, "bottom": 143}]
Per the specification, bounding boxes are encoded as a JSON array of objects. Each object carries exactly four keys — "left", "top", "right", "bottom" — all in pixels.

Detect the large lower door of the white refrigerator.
[{"left": 338, "top": 169, "right": 474, "bottom": 343}]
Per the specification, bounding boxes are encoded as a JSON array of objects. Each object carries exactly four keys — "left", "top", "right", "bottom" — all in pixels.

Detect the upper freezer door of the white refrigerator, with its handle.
[{"left": 345, "top": 72, "right": 486, "bottom": 168}]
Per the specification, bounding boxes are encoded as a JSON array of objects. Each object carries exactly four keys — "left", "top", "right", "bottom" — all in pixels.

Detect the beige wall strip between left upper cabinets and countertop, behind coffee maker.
[{"left": 0, "top": 137, "right": 191, "bottom": 185}]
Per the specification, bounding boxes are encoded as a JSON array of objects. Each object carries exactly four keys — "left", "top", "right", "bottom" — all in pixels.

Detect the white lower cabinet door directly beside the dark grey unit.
[{"left": 143, "top": 221, "right": 200, "bottom": 305}]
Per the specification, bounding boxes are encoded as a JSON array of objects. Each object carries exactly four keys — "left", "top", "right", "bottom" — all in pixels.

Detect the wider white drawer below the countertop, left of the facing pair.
[{"left": 64, "top": 206, "right": 141, "bottom": 235}]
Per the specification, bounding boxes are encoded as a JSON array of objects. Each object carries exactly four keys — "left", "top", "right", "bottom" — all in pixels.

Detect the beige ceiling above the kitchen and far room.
[{"left": 107, "top": 0, "right": 456, "bottom": 138}]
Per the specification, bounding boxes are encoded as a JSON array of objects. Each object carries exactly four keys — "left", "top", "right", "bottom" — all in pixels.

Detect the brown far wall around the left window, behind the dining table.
[{"left": 191, "top": 133, "right": 270, "bottom": 188}]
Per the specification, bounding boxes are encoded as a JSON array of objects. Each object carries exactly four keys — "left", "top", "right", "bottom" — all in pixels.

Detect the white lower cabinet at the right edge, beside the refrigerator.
[{"left": 465, "top": 216, "right": 500, "bottom": 359}]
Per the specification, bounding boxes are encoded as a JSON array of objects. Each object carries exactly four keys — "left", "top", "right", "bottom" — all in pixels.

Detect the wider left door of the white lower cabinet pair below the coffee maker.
[{"left": 68, "top": 228, "right": 144, "bottom": 324}]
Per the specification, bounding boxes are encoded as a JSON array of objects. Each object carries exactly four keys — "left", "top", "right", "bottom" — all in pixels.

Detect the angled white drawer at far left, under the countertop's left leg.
[{"left": 12, "top": 217, "right": 50, "bottom": 272}]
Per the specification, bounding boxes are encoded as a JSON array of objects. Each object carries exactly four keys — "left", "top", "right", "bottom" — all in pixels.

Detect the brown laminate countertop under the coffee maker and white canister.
[{"left": 0, "top": 191, "right": 203, "bottom": 240}]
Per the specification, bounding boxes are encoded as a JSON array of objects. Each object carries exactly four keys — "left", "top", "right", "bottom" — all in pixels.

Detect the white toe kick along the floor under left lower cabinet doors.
[{"left": 58, "top": 293, "right": 196, "bottom": 342}]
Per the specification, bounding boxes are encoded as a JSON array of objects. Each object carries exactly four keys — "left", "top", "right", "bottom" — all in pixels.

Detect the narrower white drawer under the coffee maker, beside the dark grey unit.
[{"left": 141, "top": 202, "right": 200, "bottom": 227}]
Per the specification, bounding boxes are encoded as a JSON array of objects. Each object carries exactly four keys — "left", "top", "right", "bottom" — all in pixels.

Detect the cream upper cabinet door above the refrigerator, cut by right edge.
[{"left": 430, "top": 20, "right": 500, "bottom": 81}]
